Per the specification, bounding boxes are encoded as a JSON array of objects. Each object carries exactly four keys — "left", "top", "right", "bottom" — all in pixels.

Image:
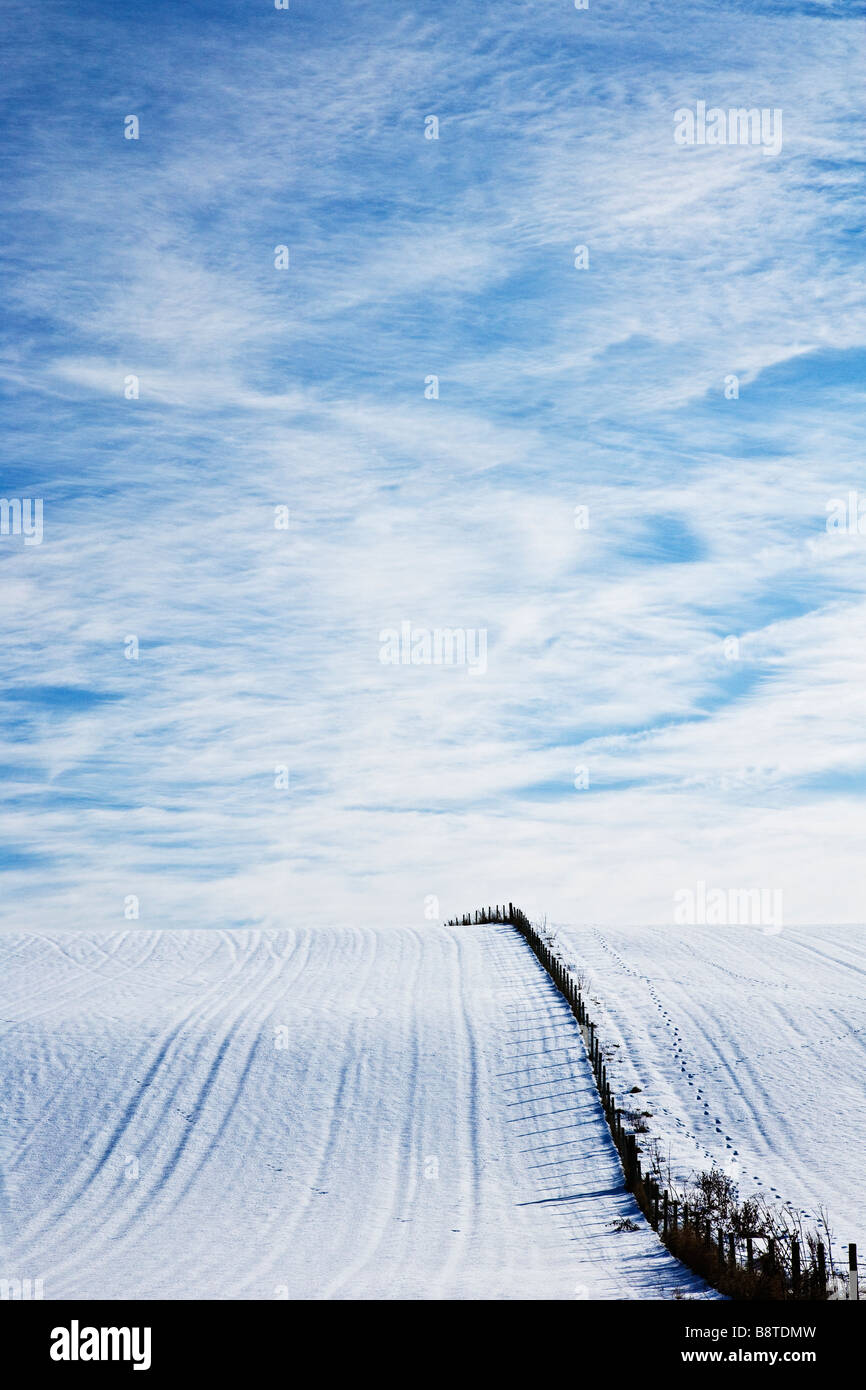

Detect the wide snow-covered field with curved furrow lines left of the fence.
[{"left": 0, "top": 924, "right": 711, "bottom": 1298}]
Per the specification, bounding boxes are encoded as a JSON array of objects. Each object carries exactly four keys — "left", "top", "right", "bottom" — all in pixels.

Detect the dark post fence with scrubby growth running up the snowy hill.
[{"left": 446, "top": 902, "right": 859, "bottom": 1298}]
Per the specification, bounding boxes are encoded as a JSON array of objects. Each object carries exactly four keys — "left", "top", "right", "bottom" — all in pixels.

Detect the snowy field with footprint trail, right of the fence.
[{"left": 556, "top": 926, "right": 866, "bottom": 1273}]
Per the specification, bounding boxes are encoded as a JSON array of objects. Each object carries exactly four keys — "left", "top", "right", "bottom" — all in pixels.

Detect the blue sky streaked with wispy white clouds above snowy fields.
[{"left": 0, "top": 0, "right": 866, "bottom": 930}]
